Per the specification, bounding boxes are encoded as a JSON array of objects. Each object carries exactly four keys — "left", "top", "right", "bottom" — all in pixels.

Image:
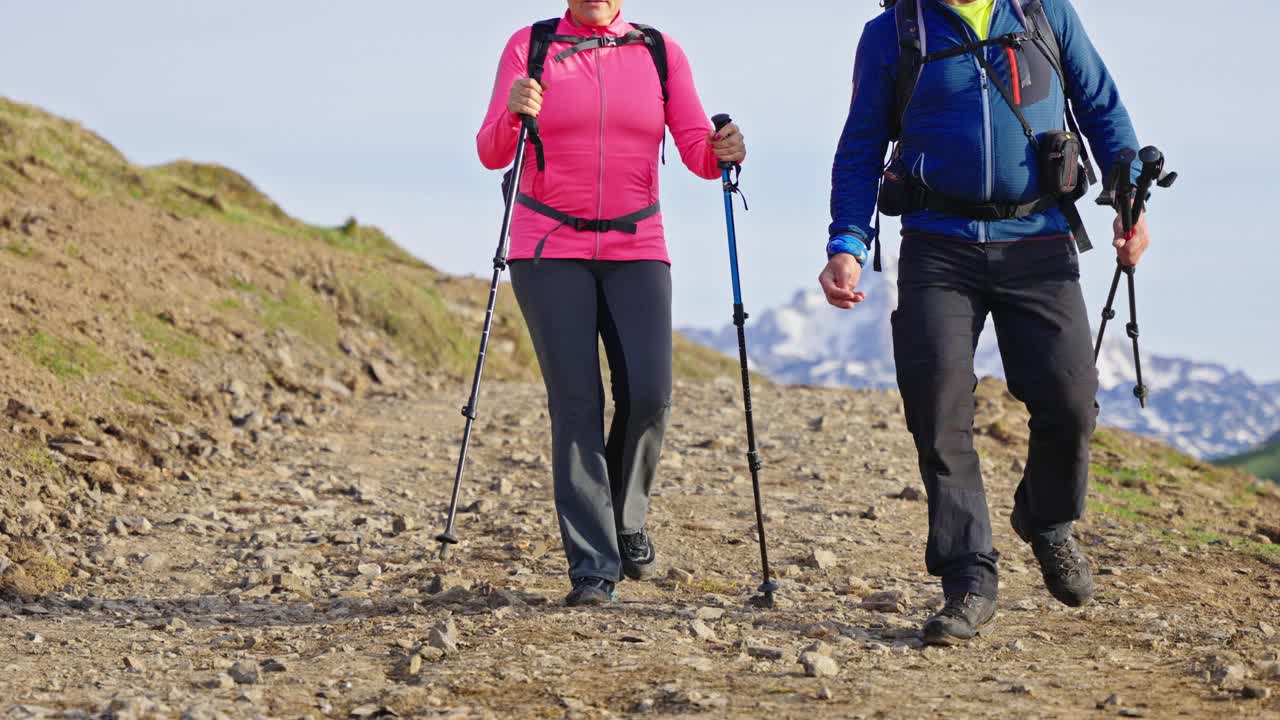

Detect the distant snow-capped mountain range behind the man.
[{"left": 682, "top": 256, "right": 1280, "bottom": 459}]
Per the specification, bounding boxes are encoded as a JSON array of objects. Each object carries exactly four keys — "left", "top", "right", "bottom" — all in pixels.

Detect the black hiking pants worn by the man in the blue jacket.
[{"left": 893, "top": 237, "right": 1098, "bottom": 598}]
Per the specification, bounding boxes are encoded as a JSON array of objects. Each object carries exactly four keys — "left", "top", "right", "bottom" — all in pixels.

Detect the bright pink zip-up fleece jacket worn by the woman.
[{"left": 476, "top": 13, "right": 721, "bottom": 263}]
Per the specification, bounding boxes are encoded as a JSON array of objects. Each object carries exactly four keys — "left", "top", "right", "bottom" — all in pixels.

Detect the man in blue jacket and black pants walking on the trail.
[{"left": 819, "top": 0, "right": 1149, "bottom": 644}]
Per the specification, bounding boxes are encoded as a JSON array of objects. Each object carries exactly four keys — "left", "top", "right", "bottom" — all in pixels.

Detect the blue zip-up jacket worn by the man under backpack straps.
[{"left": 831, "top": 0, "right": 1140, "bottom": 246}]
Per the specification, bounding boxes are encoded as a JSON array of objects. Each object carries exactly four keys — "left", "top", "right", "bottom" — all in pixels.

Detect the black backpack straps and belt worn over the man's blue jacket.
[{"left": 876, "top": 0, "right": 1097, "bottom": 256}]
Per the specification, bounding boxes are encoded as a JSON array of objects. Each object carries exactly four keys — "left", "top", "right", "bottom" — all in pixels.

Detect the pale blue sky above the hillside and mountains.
[{"left": 0, "top": 0, "right": 1280, "bottom": 380}]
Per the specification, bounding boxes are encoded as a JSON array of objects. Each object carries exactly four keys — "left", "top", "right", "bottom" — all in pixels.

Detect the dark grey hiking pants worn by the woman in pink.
[{"left": 511, "top": 260, "right": 672, "bottom": 582}]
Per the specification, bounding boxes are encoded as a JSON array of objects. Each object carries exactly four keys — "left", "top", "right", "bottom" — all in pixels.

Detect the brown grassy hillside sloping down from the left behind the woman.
[{"left": 0, "top": 97, "right": 736, "bottom": 584}]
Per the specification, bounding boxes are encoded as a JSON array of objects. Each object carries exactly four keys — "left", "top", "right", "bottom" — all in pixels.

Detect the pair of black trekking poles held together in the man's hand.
[{"left": 1093, "top": 146, "right": 1178, "bottom": 407}]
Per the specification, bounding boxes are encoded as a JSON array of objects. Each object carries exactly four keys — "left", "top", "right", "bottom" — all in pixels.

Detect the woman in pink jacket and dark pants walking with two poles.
[{"left": 476, "top": 0, "right": 746, "bottom": 606}]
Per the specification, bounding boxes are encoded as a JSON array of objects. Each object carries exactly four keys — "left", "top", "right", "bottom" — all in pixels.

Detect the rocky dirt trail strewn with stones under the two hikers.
[{"left": 0, "top": 379, "right": 1280, "bottom": 719}]
